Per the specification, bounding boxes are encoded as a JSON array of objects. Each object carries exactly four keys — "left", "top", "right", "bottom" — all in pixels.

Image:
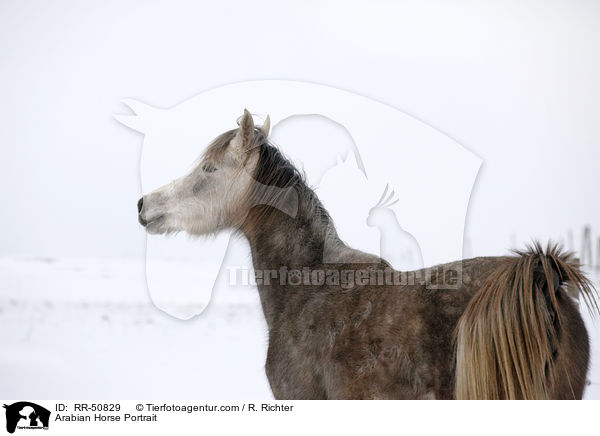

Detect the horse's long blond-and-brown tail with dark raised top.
[{"left": 454, "top": 243, "right": 598, "bottom": 399}]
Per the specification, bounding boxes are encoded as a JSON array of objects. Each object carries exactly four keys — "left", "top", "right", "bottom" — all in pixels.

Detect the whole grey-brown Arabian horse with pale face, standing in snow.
[{"left": 138, "top": 111, "right": 598, "bottom": 399}]
